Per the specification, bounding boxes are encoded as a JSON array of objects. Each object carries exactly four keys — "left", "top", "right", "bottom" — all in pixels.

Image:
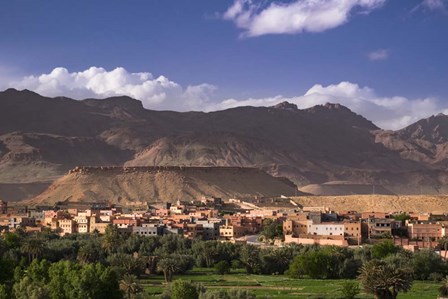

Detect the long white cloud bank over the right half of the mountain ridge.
[{"left": 209, "top": 82, "right": 448, "bottom": 129}]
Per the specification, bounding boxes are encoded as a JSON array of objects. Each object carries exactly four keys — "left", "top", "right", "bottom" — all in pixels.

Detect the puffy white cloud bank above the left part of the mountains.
[{"left": 8, "top": 67, "right": 215, "bottom": 111}]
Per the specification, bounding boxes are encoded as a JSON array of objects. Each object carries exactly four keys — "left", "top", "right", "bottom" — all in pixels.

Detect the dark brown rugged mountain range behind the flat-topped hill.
[{"left": 0, "top": 89, "right": 448, "bottom": 200}]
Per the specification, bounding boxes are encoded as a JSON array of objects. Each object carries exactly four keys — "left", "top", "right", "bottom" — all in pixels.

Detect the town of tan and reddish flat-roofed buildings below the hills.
[{"left": 0, "top": 197, "right": 448, "bottom": 257}]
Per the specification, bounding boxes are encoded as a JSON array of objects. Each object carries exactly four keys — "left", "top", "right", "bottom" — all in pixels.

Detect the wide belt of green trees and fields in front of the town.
[{"left": 0, "top": 226, "right": 448, "bottom": 299}]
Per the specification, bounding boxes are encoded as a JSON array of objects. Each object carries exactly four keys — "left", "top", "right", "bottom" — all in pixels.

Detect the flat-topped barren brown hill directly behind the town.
[{"left": 31, "top": 167, "right": 296, "bottom": 205}]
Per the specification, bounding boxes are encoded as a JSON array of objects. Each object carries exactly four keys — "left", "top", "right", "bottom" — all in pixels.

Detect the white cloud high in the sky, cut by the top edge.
[{"left": 223, "top": 0, "right": 386, "bottom": 36}]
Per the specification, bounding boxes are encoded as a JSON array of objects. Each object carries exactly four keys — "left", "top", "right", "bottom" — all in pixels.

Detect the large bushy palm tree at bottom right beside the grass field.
[{"left": 358, "top": 260, "right": 413, "bottom": 299}]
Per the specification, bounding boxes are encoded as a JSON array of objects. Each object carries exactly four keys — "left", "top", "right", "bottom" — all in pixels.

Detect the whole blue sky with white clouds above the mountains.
[{"left": 0, "top": 0, "right": 448, "bottom": 128}]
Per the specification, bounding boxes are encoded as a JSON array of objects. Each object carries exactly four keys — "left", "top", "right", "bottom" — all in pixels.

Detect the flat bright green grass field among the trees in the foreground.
[{"left": 141, "top": 268, "right": 440, "bottom": 299}]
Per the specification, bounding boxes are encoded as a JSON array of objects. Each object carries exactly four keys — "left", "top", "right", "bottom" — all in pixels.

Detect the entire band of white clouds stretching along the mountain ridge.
[{"left": 7, "top": 67, "right": 448, "bottom": 129}]
